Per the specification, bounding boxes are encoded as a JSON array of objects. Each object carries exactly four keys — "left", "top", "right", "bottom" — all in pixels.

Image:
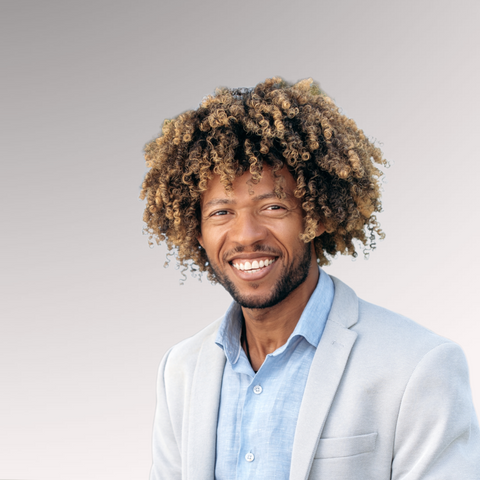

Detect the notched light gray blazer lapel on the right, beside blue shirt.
[{"left": 290, "top": 277, "right": 358, "bottom": 480}]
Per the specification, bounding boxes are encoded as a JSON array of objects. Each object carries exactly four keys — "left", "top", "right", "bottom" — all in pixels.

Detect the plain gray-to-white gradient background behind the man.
[{"left": 0, "top": 0, "right": 480, "bottom": 480}]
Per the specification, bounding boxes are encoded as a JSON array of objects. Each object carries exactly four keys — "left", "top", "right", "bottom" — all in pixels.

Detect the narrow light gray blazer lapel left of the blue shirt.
[{"left": 186, "top": 331, "right": 225, "bottom": 480}]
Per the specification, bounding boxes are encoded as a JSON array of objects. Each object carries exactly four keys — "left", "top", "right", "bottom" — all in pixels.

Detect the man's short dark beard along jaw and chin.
[{"left": 209, "top": 242, "right": 312, "bottom": 308}]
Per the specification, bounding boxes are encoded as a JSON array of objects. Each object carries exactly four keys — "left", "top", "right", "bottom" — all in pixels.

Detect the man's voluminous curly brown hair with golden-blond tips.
[{"left": 140, "top": 77, "right": 387, "bottom": 282}]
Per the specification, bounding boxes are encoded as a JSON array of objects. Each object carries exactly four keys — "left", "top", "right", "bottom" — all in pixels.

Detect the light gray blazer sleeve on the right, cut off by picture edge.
[{"left": 392, "top": 343, "right": 480, "bottom": 480}]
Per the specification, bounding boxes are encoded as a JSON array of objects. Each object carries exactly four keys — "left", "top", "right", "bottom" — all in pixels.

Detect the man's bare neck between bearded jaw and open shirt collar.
[{"left": 242, "top": 262, "right": 319, "bottom": 371}]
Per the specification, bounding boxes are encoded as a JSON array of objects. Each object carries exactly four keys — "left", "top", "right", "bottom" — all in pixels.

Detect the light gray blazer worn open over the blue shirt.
[{"left": 150, "top": 277, "right": 480, "bottom": 480}]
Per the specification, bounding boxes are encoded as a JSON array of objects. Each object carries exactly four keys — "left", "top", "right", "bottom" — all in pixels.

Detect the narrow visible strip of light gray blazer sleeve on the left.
[{"left": 150, "top": 351, "right": 182, "bottom": 480}]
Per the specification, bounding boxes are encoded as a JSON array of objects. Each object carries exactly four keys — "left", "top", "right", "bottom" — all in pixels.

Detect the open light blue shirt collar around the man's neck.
[{"left": 215, "top": 268, "right": 335, "bottom": 365}]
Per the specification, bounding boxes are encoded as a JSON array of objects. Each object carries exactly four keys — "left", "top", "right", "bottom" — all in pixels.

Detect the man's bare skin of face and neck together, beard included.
[{"left": 198, "top": 167, "right": 324, "bottom": 370}]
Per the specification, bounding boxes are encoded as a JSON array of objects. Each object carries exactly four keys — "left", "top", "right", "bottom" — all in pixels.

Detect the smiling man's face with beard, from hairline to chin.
[{"left": 198, "top": 167, "right": 322, "bottom": 308}]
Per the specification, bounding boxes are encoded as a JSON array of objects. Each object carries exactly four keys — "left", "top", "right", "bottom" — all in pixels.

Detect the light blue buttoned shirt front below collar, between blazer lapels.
[{"left": 215, "top": 341, "right": 315, "bottom": 479}]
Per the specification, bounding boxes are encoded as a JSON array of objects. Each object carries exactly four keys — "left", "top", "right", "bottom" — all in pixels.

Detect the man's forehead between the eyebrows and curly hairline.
[{"left": 202, "top": 165, "right": 297, "bottom": 205}]
